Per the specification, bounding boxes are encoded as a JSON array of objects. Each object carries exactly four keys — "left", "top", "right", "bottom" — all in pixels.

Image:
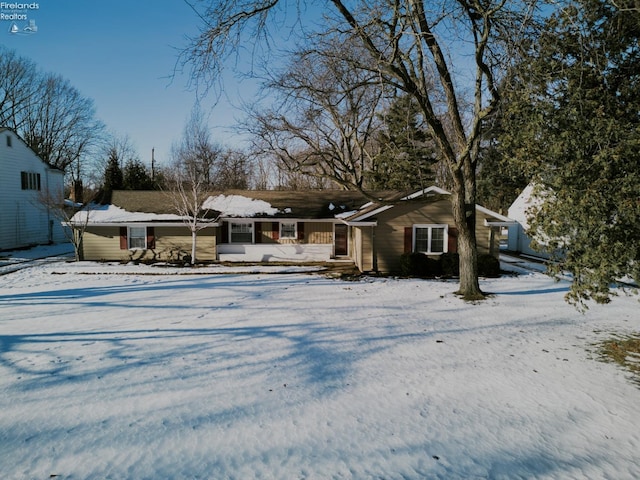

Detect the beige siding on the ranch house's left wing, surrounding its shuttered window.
[{"left": 82, "top": 226, "right": 216, "bottom": 261}]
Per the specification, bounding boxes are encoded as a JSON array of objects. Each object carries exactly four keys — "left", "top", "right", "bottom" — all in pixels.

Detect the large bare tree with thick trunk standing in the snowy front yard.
[{"left": 183, "top": 0, "right": 535, "bottom": 299}]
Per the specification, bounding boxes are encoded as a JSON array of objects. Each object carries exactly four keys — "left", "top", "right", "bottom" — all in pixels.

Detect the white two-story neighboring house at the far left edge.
[{"left": 0, "top": 127, "right": 66, "bottom": 250}]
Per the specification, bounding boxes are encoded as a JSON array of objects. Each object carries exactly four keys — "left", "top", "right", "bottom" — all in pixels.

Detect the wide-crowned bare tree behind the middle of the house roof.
[{"left": 247, "top": 36, "right": 383, "bottom": 190}]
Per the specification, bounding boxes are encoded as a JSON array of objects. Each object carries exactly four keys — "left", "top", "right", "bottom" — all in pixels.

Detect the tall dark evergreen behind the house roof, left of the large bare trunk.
[{"left": 368, "top": 95, "right": 436, "bottom": 191}]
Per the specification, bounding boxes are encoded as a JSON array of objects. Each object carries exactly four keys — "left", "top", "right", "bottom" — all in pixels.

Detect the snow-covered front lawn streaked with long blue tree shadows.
[{"left": 0, "top": 246, "right": 640, "bottom": 480}]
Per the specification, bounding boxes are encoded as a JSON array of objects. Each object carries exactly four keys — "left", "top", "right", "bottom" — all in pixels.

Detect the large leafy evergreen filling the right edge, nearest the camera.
[{"left": 501, "top": 0, "right": 640, "bottom": 306}]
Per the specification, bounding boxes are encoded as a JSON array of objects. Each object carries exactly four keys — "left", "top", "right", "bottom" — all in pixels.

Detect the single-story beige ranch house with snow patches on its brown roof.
[{"left": 72, "top": 187, "right": 508, "bottom": 273}]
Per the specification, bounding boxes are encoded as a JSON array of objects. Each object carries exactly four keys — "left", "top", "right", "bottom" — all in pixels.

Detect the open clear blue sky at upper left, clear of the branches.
[{"left": 0, "top": 0, "right": 250, "bottom": 169}]
